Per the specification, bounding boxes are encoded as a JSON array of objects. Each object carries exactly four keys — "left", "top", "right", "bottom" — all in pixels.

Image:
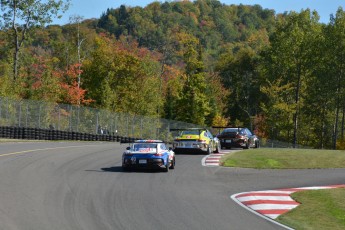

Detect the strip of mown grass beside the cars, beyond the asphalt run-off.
[{"left": 221, "top": 148, "right": 345, "bottom": 169}]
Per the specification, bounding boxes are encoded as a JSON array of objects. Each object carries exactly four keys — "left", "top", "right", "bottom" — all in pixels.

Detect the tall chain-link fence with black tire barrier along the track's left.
[{"left": 0, "top": 97, "right": 198, "bottom": 141}]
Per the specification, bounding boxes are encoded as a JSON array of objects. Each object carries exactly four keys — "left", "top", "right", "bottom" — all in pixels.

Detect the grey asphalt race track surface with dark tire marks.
[{"left": 0, "top": 142, "right": 345, "bottom": 230}]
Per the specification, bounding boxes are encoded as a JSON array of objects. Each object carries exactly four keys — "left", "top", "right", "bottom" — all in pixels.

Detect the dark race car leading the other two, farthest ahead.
[{"left": 217, "top": 127, "right": 260, "bottom": 149}]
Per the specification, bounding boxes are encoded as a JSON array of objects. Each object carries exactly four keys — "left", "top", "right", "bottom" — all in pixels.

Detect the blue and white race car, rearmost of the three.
[{"left": 122, "top": 140, "right": 175, "bottom": 172}]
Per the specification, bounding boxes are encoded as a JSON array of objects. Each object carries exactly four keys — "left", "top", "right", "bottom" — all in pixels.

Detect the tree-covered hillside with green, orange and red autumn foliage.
[{"left": 0, "top": 0, "right": 345, "bottom": 149}]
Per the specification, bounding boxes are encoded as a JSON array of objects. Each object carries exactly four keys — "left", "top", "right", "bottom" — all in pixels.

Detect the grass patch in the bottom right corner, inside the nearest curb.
[{"left": 276, "top": 188, "right": 345, "bottom": 230}]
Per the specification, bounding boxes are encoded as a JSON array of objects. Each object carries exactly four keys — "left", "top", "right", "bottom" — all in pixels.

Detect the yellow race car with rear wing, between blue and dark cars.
[{"left": 170, "top": 128, "right": 220, "bottom": 154}]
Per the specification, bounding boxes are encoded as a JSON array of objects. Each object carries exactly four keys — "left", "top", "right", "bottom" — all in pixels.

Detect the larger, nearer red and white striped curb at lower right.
[{"left": 231, "top": 184, "right": 345, "bottom": 227}]
